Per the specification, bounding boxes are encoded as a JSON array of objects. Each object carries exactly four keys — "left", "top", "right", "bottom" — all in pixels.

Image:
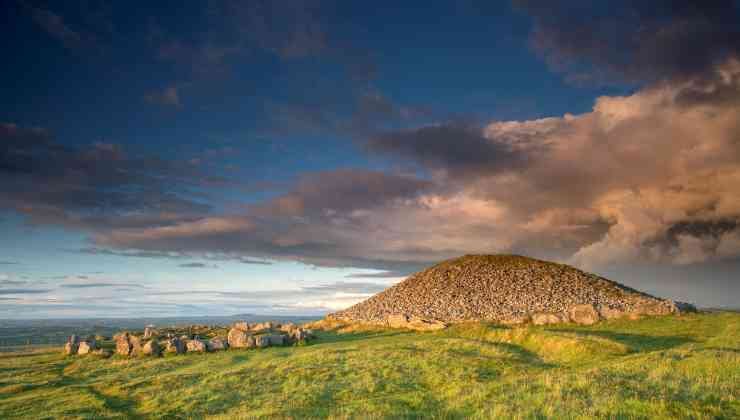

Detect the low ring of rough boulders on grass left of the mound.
[{"left": 64, "top": 321, "right": 314, "bottom": 357}]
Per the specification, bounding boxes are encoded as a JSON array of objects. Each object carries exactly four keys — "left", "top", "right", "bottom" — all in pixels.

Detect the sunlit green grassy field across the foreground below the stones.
[{"left": 0, "top": 313, "right": 740, "bottom": 419}]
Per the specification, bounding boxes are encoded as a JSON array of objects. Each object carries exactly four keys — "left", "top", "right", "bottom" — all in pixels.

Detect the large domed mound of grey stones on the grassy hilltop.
[{"left": 329, "top": 255, "right": 692, "bottom": 329}]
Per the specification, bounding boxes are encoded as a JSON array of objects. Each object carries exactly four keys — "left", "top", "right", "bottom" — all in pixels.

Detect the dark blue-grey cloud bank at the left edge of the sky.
[{"left": 0, "top": 123, "right": 214, "bottom": 229}]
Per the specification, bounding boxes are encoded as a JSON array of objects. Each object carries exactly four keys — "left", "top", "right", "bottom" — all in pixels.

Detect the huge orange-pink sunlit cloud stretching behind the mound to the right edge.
[{"left": 89, "top": 60, "right": 740, "bottom": 272}]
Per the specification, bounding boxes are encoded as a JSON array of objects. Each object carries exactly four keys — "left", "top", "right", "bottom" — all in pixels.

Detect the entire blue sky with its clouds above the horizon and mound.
[{"left": 0, "top": 0, "right": 740, "bottom": 318}]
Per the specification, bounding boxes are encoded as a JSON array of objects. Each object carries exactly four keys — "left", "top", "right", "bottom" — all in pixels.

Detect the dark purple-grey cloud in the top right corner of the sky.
[{"left": 515, "top": 0, "right": 740, "bottom": 82}]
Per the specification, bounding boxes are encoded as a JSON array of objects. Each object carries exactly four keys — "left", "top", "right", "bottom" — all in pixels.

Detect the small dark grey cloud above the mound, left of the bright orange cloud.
[{"left": 368, "top": 123, "right": 531, "bottom": 180}]
